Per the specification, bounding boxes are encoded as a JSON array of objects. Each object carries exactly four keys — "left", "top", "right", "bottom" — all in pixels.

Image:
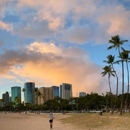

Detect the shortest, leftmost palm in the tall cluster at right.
[{"left": 101, "top": 65, "right": 115, "bottom": 113}]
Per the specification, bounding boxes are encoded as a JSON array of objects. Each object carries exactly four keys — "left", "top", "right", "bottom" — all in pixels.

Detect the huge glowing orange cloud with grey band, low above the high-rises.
[{"left": 0, "top": 42, "right": 109, "bottom": 95}]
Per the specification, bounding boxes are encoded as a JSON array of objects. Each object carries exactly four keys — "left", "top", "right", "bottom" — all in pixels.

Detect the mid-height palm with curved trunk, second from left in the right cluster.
[{"left": 104, "top": 55, "right": 118, "bottom": 114}]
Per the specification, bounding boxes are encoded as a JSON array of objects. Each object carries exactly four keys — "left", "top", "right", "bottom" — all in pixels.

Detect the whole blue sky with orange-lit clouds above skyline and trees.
[{"left": 0, "top": 0, "right": 130, "bottom": 98}]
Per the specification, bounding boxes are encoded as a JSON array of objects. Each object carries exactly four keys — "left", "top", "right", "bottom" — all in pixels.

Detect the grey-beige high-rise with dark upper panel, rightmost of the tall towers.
[{"left": 60, "top": 83, "right": 72, "bottom": 99}]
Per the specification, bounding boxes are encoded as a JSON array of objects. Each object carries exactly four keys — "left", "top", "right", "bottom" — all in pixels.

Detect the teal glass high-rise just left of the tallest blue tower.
[{"left": 11, "top": 86, "right": 21, "bottom": 102}]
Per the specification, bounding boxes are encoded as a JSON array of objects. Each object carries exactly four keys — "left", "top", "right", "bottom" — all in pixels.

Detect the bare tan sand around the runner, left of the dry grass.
[{"left": 0, "top": 113, "right": 78, "bottom": 130}]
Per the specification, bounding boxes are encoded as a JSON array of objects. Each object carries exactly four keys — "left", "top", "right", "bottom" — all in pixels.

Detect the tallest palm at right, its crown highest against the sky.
[{"left": 108, "top": 35, "right": 128, "bottom": 115}]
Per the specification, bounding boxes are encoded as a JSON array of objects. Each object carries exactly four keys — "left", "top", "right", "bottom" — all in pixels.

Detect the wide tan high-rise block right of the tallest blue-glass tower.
[{"left": 38, "top": 87, "right": 54, "bottom": 104}]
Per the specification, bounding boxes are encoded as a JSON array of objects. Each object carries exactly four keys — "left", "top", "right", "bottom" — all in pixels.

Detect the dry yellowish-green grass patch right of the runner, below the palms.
[{"left": 61, "top": 113, "right": 130, "bottom": 130}]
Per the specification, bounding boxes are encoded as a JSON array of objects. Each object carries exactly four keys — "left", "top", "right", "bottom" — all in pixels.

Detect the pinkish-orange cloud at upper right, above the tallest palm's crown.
[{"left": 97, "top": 5, "right": 130, "bottom": 36}]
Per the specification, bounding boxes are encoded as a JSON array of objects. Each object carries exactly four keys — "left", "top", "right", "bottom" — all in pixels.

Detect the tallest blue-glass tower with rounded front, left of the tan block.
[{"left": 24, "top": 82, "right": 35, "bottom": 104}]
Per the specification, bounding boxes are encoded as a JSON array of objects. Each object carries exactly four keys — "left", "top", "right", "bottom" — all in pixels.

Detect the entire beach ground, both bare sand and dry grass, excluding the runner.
[{"left": 0, "top": 113, "right": 130, "bottom": 130}]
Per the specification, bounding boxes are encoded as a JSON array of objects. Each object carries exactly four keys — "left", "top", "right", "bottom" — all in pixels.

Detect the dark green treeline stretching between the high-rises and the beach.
[{"left": 0, "top": 92, "right": 130, "bottom": 112}]
